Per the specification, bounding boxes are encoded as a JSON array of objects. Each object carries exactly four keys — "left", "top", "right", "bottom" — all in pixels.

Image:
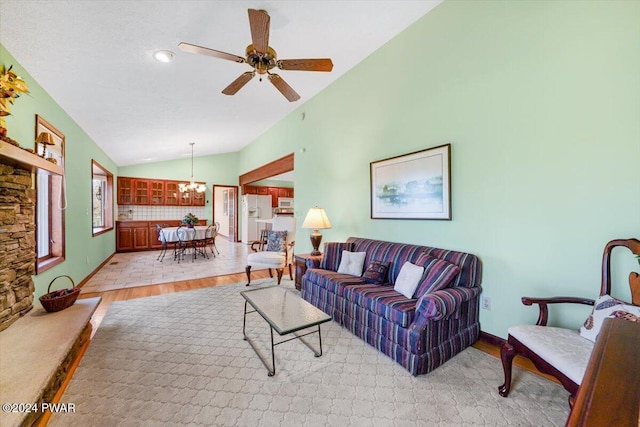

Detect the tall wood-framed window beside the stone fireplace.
[{"left": 35, "top": 115, "right": 66, "bottom": 274}]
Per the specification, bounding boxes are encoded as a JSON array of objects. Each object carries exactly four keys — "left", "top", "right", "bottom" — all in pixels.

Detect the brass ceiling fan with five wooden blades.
[{"left": 178, "top": 9, "right": 333, "bottom": 102}]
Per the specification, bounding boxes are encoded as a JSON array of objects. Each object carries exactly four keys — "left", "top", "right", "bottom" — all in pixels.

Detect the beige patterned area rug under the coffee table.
[{"left": 49, "top": 279, "right": 568, "bottom": 427}]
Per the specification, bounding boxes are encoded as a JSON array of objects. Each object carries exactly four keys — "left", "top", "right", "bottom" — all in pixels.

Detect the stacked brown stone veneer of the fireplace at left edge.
[{"left": 0, "top": 162, "right": 36, "bottom": 331}]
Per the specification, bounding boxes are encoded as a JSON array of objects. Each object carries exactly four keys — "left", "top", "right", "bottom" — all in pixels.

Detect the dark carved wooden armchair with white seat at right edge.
[{"left": 498, "top": 239, "right": 640, "bottom": 406}]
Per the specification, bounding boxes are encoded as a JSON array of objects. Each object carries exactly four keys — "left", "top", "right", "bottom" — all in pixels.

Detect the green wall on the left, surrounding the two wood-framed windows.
[{"left": 0, "top": 45, "right": 117, "bottom": 301}]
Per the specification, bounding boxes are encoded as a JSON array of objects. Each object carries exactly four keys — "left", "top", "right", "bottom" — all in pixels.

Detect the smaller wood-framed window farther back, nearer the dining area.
[{"left": 91, "top": 160, "right": 113, "bottom": 236}]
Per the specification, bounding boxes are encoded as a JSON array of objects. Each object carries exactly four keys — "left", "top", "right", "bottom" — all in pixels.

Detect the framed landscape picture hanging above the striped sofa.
[{"left": 370, "top": 144, "right": 451, "bottom": 221}]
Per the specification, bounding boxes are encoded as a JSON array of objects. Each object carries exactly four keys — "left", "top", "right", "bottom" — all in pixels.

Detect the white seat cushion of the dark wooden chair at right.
[{"left": 509, "top": 326, "right": 593, "bottom": 385}]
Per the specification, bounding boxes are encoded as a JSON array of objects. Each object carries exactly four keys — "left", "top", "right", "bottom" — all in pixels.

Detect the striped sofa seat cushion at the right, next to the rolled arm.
[{"left": 343, "top": 285, "right": 417, "bottom": 328}]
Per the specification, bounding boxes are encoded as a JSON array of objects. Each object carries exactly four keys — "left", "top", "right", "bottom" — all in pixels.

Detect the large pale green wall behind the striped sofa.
[{"left": 239, "top": 0, "right": 640, "bottom": 337}]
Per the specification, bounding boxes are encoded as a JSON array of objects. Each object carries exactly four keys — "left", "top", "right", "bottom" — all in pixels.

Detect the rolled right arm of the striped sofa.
[{"left": 411, "top": 286, "right": 482, "bottom": 329}]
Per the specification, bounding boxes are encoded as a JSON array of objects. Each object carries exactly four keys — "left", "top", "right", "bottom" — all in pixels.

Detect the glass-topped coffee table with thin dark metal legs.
[{"left": 240, "top": 286, "right": 331, "bottom": 377}]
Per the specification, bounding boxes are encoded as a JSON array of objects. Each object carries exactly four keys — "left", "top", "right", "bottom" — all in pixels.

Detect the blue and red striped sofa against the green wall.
[{"left": 301, "top": 237, "right": 482, "bottom": 375}]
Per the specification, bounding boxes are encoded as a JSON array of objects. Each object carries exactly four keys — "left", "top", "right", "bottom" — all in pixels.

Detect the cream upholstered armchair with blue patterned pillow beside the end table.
[{"left": 245, "top": 216, "right": 296, "bottom": 286}]
